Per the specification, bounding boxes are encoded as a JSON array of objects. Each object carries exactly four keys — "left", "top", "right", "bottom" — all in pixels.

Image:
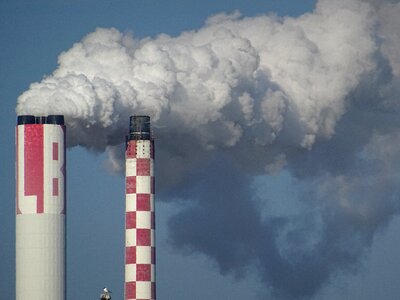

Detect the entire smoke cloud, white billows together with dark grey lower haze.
[{"left": 17, "top": 0, "right": 400, "bottom": 298}]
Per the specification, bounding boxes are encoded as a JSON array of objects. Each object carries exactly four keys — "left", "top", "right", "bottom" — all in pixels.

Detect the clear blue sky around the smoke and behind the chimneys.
[{"left": 0, "top": 0, "right": 400, "bottom": 300}]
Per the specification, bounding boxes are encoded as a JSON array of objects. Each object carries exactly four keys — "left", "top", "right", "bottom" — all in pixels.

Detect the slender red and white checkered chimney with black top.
[{"left": 125, "top": 116, "right": 156, "bottom": 300}]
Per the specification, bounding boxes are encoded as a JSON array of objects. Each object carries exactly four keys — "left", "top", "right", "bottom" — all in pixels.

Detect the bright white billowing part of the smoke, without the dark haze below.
[{"left": 17, "top": 1, "right": 377, "bottom": 157}]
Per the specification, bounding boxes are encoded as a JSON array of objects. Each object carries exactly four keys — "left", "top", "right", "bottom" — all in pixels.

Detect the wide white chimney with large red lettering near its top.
[{"left": 16, "top": 115, "right": 66, "bottom": 300}]
